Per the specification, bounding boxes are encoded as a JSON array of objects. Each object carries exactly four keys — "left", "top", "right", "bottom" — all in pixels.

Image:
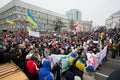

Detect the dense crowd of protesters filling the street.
[{"left": 0, "top": 29, "right": 120, "bottom": 80}]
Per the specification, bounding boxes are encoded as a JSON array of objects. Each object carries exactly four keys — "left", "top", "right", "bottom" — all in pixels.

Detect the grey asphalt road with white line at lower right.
[{"left": 95, "top": 57, "right": 120, "bottom": 80}]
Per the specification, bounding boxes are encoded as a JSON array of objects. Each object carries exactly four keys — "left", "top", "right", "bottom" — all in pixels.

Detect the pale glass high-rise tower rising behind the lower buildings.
[{"left": 66, "top": 9, "right": 81, "bottom": 21}]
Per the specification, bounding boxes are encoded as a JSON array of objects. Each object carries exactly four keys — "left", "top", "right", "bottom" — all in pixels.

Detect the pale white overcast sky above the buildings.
[{"left": 0, "top": 0, "right": 120, "bottom": 25}]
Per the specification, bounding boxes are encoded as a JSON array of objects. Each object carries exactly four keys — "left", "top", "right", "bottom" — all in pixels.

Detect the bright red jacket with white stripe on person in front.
[{"left": 26, "top": 59, "right": 39, "bottom": 74}]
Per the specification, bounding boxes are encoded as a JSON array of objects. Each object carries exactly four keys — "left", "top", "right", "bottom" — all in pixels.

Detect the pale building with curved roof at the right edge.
[{"left": 105, "top": 11, "right": 120, "bottom": 29}]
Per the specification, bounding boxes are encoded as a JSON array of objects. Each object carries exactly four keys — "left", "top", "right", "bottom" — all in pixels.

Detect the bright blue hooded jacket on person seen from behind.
[{"left": 39, "top": 61, "right": 53, "bottom": 80}]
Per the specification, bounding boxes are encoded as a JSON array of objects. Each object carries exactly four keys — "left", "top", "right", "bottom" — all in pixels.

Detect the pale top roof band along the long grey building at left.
[{"left": 0, "top": 0, "right": 68, "bottom": 19}]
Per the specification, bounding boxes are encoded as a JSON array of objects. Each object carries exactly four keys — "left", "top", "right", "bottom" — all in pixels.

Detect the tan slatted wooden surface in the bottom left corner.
[{"left": 0, "top": 63, "right": 28, "bottom": 80}]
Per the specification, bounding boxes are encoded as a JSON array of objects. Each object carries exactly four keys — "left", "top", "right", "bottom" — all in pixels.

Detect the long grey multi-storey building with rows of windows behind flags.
[{"left": 0, "top": 0, "right": 68, "bottom": 30}]
